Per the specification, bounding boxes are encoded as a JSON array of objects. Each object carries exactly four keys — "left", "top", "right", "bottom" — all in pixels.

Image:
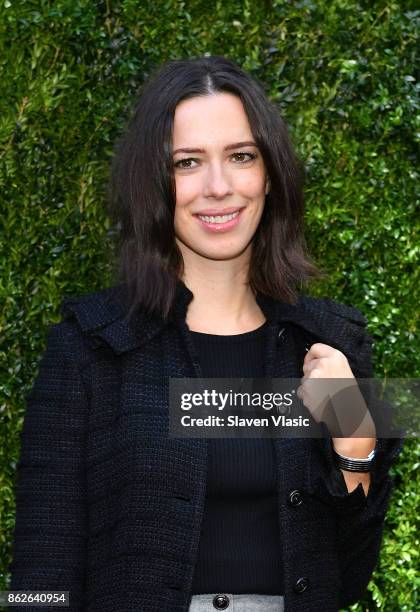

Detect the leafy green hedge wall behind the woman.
[{"left": 0, "top": 0, "right": 420, "bottom": 612}]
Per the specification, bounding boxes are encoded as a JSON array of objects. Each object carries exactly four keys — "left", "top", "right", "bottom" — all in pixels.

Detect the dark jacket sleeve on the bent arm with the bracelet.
[{"left": 310, "top": 332, "right": 403, "bottom": 608}]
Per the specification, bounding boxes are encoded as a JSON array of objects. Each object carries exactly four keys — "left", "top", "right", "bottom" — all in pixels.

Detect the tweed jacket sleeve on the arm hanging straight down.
[{"left": 9, "top": 321, "right": 88, "bottom": 612}]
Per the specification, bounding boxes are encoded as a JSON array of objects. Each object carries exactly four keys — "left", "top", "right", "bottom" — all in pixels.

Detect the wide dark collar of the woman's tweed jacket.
[{"left": 61, "top": 280, "right": 366, "bottom": 356}]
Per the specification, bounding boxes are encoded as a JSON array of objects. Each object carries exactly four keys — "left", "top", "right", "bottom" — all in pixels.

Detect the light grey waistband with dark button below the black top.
[{"left": 188, "top": 593, "right": 284, "bottom": 612}]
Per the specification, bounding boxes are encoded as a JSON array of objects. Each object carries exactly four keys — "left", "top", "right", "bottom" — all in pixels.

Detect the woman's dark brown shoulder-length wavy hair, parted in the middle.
[{"left": 108, "top": 56, "right": 323, "bottom": 319}]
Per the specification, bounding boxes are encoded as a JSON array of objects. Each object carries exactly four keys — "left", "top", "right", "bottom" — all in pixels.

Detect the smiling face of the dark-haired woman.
[{"left": 172, "top": 93, "right": 269, "bottom": 268}]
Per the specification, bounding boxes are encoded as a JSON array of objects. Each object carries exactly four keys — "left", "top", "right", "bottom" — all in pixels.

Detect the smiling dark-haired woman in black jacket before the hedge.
[{"left": 10, "top": 56, "right": 401, "bottom": 612}]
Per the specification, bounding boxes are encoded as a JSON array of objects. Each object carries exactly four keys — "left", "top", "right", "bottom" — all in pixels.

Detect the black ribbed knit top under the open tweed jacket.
[{"left": 191, "top": 323, "right": 283, "bottom": 594}]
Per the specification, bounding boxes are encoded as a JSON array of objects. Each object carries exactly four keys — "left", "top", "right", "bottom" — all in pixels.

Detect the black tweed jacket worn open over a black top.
[{"left": 9, "top": 282, "right": 402, "bottom": 612}]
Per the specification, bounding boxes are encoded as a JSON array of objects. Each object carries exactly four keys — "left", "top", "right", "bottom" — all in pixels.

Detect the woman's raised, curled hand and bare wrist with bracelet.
[{"left": 297, "top": 342, "right": 376, "bottom": 495}]
